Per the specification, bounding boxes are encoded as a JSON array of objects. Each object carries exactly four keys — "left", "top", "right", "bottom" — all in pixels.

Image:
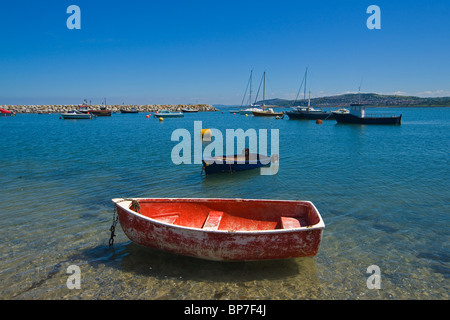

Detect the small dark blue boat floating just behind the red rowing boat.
[{"left": 202, "top": 153, "right": 276, "bottom": 175}]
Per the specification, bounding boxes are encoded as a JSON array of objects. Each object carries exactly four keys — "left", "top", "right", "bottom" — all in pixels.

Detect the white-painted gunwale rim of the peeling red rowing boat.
[{"left": 112, "top": 198, "right": 325, "bottom": 235}]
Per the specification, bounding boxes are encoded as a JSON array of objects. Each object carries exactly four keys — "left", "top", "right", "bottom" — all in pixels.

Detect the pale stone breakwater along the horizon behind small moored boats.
[{"left": 0, "top": 104, "right": 219, "bottom": 113}]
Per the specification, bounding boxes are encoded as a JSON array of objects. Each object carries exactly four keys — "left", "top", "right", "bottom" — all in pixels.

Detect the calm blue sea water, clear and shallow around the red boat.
[{"left": 0, "top": 108, "right": 450, "bottom": 301}]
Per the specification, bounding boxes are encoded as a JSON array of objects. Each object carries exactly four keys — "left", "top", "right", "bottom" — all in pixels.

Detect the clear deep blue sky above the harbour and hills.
[{"left": 0, "top": 0, "right": 450, "bottom": 105}]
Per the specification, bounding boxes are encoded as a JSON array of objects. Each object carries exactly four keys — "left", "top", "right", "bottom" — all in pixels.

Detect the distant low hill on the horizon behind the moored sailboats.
[{"left": 258, "top": 93, "right": 450, "bottom": 108}]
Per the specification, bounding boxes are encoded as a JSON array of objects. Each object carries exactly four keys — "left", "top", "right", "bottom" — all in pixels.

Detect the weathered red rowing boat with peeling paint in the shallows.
[{"left": 112, "top": 198, "right": 325, "bottom": 261}]
